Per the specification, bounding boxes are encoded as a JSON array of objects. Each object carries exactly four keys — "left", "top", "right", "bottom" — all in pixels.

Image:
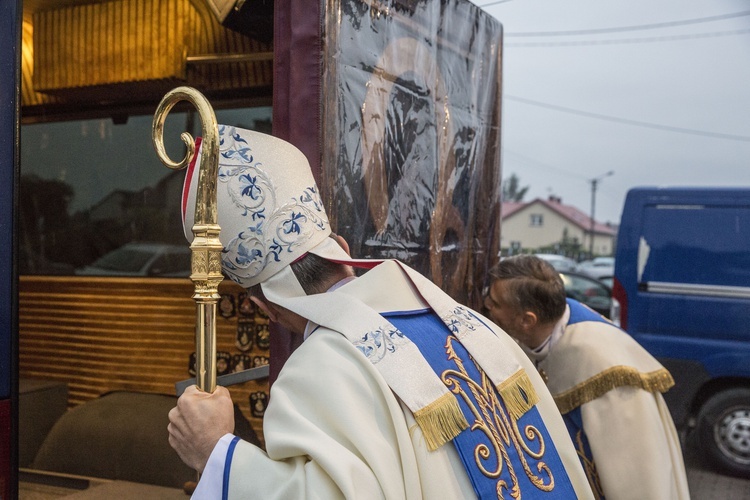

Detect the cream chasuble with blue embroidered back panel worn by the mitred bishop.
[{"left": 216, "top": 261, "right": 593, "bottom": 500}]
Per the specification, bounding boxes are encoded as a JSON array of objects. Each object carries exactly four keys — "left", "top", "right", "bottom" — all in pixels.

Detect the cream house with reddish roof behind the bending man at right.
[{"left": 500, "top": 196, "right": 617, "bottom": 257}]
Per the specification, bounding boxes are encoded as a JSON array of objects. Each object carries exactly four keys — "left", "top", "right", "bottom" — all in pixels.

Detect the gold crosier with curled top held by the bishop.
[{"left": 151, "top": 87, "right": 223, "bottom": 392}]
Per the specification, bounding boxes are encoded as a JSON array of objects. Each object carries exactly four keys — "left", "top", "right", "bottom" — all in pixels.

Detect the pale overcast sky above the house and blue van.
[{"left": 482, "top": 0, "right": 750, "bottom": 223}]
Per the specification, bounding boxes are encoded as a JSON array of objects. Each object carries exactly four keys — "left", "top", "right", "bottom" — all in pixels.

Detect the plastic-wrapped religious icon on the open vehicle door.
[{"left": 321, "top": 0, "right": 502, "bottom": 308}]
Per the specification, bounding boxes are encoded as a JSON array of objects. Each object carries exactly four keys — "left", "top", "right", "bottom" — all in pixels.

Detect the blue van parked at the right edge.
[{"left": 613, "top": 188, "right": 750, "bottom": 477}]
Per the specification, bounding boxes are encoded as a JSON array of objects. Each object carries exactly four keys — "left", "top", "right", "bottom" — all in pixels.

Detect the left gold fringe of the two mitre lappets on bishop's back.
[{"left": 414, "top": 392, "right": 469, "bottom": 451}]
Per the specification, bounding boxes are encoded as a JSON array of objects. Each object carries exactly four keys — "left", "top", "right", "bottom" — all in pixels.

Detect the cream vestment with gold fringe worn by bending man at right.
[{"left": 538, "top": 300, "right": 690, "bottom": 500}]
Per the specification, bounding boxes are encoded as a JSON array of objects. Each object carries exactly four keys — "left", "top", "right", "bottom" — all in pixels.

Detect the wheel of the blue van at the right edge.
[{"left": 697, "top": 388, "right": 750, "bottom": 478}]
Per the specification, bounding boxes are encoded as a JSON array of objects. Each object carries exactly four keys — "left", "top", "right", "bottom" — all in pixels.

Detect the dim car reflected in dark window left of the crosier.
[{"left": 75, "top": 243, "right": 190, "bottom": 277}]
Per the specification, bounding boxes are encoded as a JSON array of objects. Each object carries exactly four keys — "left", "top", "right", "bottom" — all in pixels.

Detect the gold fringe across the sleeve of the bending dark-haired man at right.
[{"left": 554, "top": 366, "right": 674, "bottom": 415}]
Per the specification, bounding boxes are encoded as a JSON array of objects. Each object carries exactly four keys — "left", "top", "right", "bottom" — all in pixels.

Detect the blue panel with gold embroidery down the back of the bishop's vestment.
[{"left": 383, "top": 309, "right": 576, "bottom": 500}]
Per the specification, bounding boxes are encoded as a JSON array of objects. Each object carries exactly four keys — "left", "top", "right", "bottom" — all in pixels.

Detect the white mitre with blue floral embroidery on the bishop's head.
[{"left": 182, "top": 125, "right": 358, "bottom": 296}]
